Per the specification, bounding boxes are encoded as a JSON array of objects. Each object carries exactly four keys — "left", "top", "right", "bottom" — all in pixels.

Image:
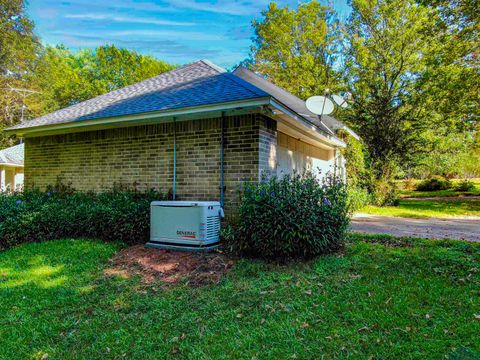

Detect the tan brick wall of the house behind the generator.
[{"left": 25, "top": 114, "right": 276, "bottom": 211}]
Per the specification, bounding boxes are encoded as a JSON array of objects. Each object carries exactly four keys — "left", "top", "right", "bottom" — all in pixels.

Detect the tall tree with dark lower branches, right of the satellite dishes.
[{"left": 345, "top": 0, "right": 435, "bottom": 173}]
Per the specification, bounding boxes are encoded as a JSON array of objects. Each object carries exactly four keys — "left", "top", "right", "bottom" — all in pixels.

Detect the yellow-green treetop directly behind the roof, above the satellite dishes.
[{"left": 250, "top": 0, "right": 341, "bottom": 99}]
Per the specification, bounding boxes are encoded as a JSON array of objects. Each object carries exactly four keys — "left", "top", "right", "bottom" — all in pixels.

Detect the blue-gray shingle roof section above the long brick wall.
[{"left": 10, "top": 60, "right": 269, "bottom": 129}]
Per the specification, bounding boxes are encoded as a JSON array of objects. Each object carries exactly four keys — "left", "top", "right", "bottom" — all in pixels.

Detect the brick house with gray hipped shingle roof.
[{"left": 7, "top": 60, "right": 354, "bottom": 211}]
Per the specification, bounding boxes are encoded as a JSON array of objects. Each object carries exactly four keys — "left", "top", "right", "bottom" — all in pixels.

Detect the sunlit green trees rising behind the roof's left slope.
[{"left": 31, "top": 45, "right": 174, "bottom": 115}]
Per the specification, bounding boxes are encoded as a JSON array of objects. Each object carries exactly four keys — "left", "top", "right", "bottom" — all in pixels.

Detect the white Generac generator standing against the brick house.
[{"left": 145, "top": 201, "right": 224, "bottom": 251}]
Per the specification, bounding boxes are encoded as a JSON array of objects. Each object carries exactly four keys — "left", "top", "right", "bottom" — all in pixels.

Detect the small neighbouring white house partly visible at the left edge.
[{"left": 0, "top": 144, "right": 24, "bottom": 191}]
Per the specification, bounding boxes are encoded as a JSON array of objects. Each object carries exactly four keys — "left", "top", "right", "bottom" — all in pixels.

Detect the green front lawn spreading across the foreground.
[{"left": 0, "top": 235, "right": 480, "bottom": 359}]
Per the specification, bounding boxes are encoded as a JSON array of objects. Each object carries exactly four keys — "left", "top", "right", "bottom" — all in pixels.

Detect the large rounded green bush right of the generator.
[{"left": 234, "top": 174, "right": 349, "bottom": 259}]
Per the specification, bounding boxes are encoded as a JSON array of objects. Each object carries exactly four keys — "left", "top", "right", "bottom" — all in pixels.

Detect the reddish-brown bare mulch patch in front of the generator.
[{"left": 105, "top": 245, "right": 234, "bottom": 287}]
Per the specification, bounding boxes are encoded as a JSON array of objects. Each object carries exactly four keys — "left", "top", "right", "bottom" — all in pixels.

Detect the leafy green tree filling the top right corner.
[{"left": 419, "top": 0, "right": 480, "bottom": 137}]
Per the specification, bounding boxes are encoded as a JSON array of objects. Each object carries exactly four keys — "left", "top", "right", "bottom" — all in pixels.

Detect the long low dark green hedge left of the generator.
[{"left": 0, "top": 191, "right": 165, "bottom": 249}]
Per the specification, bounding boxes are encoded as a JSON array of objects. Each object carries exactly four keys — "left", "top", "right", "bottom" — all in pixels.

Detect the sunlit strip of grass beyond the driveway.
[{"left": 359, "top": 198, "right": 480, "bottom": 218}]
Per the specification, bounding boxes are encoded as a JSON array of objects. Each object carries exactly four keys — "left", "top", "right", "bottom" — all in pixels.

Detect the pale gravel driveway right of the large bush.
[{"left": 351, "top": 214, "right": 480, "bottom": 242}]
